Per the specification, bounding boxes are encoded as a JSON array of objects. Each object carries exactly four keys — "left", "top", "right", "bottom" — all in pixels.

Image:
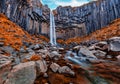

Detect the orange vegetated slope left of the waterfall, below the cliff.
[{"left": 0, "top": 14, "right": 44, "bottom": 50}]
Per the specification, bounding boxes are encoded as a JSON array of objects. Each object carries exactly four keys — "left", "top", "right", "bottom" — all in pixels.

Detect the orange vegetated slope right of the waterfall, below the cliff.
[{"left": 65, "top": 19, "right": 120, "bottom": 44}]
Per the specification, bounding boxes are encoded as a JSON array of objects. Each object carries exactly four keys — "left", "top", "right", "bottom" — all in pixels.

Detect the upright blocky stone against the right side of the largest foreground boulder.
[{"left": 36, "top": 60, "right": 48, "bottom": 75}]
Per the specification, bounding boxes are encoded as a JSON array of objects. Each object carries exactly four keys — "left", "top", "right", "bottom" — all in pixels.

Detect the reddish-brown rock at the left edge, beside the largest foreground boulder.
[{"left": 0, "top": 55, "right": 12, "bottom": 84}]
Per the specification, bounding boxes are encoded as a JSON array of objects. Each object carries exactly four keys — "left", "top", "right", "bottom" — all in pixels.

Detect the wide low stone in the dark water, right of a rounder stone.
[{"left": 58, "top": 66, "right": 75, "bottom": 76}]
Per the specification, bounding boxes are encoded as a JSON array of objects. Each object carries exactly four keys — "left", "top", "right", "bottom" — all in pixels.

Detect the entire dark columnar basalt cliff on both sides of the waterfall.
[{"left": 0, "top": 0, "right": 120, "bottom": 39}]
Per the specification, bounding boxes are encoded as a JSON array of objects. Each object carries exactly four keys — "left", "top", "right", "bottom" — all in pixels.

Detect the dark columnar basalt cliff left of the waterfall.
[{"left": 0, "top": 0, "right": 50, "bottom": 34}]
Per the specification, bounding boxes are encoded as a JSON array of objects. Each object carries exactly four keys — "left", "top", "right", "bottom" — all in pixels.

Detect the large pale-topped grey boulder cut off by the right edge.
[{"left": 109, "top": 37, "right": 120, "bottom": 51}]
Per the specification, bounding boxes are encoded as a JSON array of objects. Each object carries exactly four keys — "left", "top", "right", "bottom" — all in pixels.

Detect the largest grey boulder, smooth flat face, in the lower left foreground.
[{"left": 4, "top": 62, "right": 36, "bottom": 84}]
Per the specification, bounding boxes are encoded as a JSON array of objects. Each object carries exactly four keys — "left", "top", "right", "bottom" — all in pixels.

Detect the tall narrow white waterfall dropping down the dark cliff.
[{"left": 50, "top": 11, "right": 57, "bottom": 45}]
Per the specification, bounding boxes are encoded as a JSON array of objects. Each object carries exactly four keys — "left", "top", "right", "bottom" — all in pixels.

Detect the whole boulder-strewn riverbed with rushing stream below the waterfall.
[{"left": 0, "top": 37, "right": 120, "bottom": 84}]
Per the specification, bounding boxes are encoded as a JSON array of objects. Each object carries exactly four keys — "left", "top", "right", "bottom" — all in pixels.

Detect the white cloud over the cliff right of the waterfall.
[{"left": 55, "top": 0, "right": 88, "bottom": 7}]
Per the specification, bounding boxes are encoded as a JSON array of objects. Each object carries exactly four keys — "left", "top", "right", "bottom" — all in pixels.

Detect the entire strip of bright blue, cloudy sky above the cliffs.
[{"left": 41, "top": 0, "right": 95, "bottom": 10}]
